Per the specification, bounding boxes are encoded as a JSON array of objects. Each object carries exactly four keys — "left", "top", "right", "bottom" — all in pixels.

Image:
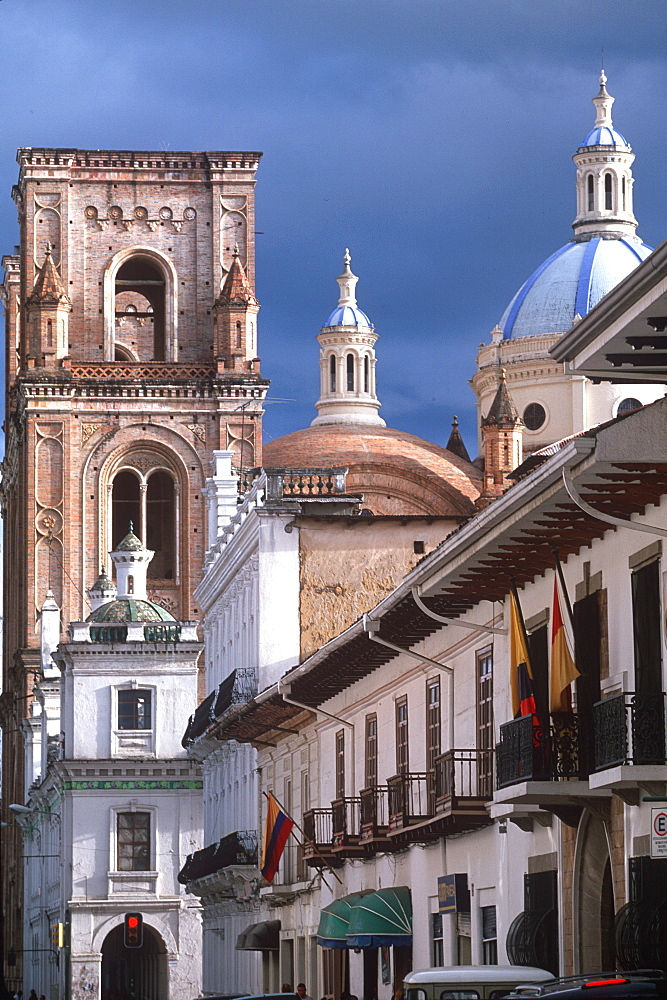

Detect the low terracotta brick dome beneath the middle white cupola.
[{"left": 262, "top": 424, "right": 482, "bottom": 517}]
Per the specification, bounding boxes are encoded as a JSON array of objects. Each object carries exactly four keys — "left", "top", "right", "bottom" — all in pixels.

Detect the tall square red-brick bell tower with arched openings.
[{"left": 0, "top": 149, "right": 268, "bottom": 976}]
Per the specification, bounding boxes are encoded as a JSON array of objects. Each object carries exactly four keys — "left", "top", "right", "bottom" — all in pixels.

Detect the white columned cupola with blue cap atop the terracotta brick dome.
[{"left": 311, "top": 249, "right": 385, "bottom": 427}]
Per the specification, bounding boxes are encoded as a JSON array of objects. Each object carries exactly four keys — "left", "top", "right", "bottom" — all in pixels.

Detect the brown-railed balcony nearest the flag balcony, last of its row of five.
[{"left": 435, "top": 750, "right": 493, "bottom": 833}]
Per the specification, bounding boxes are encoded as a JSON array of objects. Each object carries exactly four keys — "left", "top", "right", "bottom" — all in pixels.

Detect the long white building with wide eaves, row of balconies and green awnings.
[{"left": 201, "top": 340, "right": 667, "bottom": 1000}]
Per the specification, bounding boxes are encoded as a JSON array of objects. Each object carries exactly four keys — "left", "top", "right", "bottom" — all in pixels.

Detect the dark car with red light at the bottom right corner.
[{"left": 508, "top": 969, "right": 667, "bottom": 1000}]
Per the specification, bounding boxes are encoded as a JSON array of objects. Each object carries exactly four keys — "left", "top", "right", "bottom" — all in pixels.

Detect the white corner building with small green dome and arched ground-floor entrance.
[{"left": 17, "top": 533, "right": 202, "bottom": 1000}]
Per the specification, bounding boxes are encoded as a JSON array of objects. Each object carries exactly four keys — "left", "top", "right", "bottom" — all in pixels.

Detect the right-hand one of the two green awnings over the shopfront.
[{"left": 346, "top": 885, "right": 412, "bottom": 948}]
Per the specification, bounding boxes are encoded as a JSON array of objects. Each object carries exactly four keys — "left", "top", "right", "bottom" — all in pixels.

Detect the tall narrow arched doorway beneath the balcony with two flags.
[{"left": 575, "top": 814, "right": 615, "bottom": 973}]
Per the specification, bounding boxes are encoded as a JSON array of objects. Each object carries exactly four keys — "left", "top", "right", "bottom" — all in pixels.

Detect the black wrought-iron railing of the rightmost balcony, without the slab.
[{"left": 593, "top": 691, "right": 667, "bottom": 771}]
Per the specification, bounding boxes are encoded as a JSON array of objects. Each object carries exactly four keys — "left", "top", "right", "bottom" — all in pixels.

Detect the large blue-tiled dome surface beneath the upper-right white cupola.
[{"left": 499, "top": 236, "right": 652, "bottom": 340}]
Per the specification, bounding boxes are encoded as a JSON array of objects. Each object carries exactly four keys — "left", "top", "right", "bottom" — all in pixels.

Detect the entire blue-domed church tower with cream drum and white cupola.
[{"left": 471, "top": 72, "right": 664, "bottom": 454}]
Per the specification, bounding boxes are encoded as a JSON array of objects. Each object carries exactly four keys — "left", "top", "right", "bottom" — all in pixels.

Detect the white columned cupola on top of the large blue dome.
[{"left": 572, "top": 70, "right": 637, "bottom": 239}]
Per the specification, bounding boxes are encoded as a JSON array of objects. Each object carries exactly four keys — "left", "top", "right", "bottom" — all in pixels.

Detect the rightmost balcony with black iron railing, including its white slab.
[{"left": 590, "top": 691, "right": 667, "bottom": 805}]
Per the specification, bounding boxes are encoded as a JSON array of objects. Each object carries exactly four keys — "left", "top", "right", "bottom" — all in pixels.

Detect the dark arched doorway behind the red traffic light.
[{"left": 101, "top": 923, "right": 169, "bottom": 1000}]
